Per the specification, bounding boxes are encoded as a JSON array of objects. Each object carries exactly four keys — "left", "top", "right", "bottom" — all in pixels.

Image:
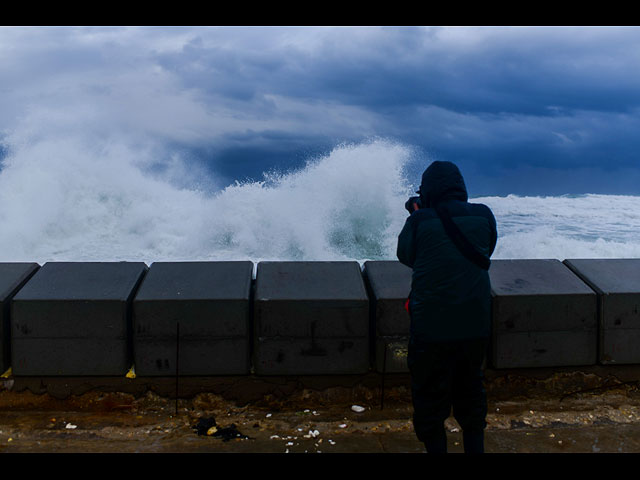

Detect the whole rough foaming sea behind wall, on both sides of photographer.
[{"left": 0, "top": 139, "right": 640, "bottom": 264}]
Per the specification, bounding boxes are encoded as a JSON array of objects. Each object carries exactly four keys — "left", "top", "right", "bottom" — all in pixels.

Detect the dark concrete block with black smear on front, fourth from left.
[{"left": 254, "top": 262, "right": 369, "bottom": 375}]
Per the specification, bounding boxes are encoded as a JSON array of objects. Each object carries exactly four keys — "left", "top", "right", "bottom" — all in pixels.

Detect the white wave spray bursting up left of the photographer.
[{"left": 0, "top": 137, "right": 412, "bottom": 263}]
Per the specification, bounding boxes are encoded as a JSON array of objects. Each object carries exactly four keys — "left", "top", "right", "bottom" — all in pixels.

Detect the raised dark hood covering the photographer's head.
[{"left": 420, "top": 161, "right": 468, "bottom": 207}]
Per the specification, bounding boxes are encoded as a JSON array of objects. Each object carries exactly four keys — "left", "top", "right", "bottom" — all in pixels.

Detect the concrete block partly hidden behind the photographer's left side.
[{"left": 363, "top": 261, "right": 412, "bottom": 373}]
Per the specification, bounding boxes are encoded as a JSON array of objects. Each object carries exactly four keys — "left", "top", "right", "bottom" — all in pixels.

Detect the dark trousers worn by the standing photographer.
[{"left": 407, "top": 336, "right": 487, "bottom": 453}]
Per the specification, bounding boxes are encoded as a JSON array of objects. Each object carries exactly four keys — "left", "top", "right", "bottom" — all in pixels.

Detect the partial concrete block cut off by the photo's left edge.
[{"left": 0, "top": 262, "right": 40, "bottom": 372}]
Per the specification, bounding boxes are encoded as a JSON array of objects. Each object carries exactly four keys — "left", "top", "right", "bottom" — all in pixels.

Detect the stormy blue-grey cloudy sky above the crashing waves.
[{"left": 0, "top": 27, "right": 640, "bottom": 196}]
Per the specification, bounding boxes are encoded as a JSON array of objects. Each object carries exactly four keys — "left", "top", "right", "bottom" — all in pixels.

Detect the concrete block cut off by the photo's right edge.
[{"left": 564, "top": 258, "right": 640, "bottom": 364}]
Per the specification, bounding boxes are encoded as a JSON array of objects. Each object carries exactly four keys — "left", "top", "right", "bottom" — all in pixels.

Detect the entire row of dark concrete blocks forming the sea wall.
[{"left": 0, "top": 259, "right": 640, "bottom": 377}]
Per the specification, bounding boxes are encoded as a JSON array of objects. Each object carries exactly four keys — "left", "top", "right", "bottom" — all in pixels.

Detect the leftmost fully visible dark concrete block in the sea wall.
[{"left": 11, "top": 262, "right": 147, "bottom": 376}]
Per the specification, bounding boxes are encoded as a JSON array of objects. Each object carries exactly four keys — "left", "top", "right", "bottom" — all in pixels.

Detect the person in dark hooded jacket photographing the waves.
[{"left": 397, "top": 161, "right": 497, "bottom": 453}]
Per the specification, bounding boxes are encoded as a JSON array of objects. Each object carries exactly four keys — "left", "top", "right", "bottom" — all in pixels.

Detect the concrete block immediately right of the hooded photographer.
[{"left": 489, "top": 260, "right": 598, "bottom": 368}]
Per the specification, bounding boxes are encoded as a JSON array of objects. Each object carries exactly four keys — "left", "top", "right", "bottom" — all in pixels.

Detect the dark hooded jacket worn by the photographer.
[{"left": 397, "top": 161, "right": 497, "bottom": 342}]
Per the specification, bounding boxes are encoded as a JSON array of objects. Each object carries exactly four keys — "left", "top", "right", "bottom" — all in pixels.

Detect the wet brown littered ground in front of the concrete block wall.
[{"left": 0, "top": 373, "right": 640, "bottom": 454}]
